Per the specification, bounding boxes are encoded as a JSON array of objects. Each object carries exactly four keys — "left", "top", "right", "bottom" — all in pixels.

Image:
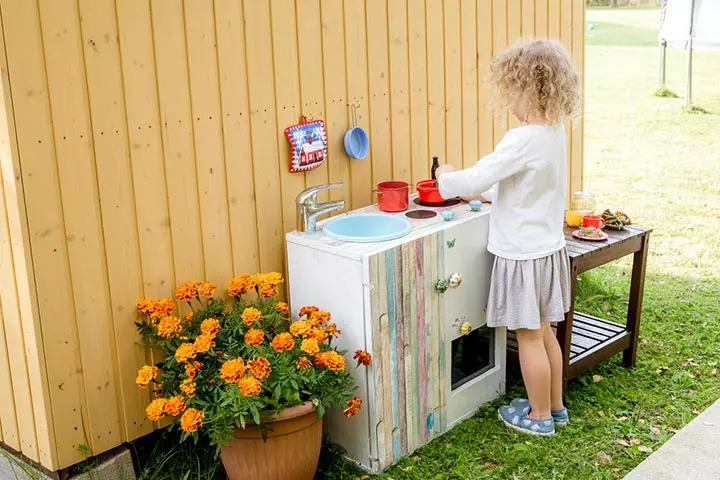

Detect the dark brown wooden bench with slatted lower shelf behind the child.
[{"left": 508, "top": 225, "right": 651, "bottom": 390}]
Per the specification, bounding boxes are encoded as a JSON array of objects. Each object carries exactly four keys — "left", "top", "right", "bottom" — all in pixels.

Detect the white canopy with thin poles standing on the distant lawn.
[{"left": 658, "top": 0, "right": 720, "bottom": 107}]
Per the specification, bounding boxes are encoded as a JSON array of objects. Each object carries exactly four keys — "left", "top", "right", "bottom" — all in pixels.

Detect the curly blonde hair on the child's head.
[{"left": 490, "top": 40, "right": 581, "bottom": 125}]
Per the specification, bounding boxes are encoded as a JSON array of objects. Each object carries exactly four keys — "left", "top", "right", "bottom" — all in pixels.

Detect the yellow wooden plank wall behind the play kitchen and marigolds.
[{"left": 0, "top": 0, "right": 584, "bottom": 470}]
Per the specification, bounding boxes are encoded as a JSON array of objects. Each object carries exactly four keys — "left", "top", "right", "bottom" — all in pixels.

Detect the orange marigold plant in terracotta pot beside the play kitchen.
[{"left": 136, "top": 273, "right": 371, "bottom": 480}]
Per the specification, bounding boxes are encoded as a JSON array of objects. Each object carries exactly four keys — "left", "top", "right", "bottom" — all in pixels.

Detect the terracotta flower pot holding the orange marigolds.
[{"left": 220, "top": 402, "right": 322, "bottom": 480}]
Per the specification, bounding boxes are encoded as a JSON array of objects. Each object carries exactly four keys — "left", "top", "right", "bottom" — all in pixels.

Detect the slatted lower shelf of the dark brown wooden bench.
[{"left": 507, "top": 312, "right": 632, "bottom": 379}]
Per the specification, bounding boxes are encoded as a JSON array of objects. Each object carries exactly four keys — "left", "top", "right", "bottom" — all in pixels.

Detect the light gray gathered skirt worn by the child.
[{"left": 487, "top": 248, "right": 570, "bottom": 330}]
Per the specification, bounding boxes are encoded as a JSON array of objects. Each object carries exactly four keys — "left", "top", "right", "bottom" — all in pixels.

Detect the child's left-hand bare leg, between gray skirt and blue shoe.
[{"left": 516, "top": 329, "right": 551, "bottom": 420}]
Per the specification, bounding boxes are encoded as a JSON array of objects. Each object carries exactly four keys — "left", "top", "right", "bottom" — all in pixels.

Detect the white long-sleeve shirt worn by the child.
[{"left": 438, "top": 124, "right": 567, "bottom": 260}]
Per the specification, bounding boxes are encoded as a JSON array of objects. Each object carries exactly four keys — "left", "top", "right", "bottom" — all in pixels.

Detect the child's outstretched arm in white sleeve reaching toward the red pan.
[{"left": 437, "top": 130, "right": 528, "bottom": 201}]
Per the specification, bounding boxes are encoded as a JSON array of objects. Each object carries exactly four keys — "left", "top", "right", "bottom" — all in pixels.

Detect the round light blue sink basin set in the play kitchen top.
[{"left": 323, "top": 213, "right": 412, "bottom": 243}]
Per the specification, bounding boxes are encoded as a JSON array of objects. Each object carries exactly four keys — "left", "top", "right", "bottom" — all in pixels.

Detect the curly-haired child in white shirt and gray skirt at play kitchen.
[{"left": 436, "top": 40, "right": 580, "bottom": 436}]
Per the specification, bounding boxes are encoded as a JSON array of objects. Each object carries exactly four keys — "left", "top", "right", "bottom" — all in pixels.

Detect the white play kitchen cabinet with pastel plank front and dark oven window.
[{"left": 288, "top": 205, "right": 505, "bottom": 472}]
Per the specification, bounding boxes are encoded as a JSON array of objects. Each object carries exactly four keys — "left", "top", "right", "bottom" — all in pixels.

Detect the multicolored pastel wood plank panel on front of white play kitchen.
[{"left": 370, "top": 233, "right": 449, "bottom": 469}]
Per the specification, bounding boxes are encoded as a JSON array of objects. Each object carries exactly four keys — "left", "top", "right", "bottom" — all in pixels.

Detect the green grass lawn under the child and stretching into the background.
[{"left": 135, "top": 9, "right": 720, "bottom": 480}]
